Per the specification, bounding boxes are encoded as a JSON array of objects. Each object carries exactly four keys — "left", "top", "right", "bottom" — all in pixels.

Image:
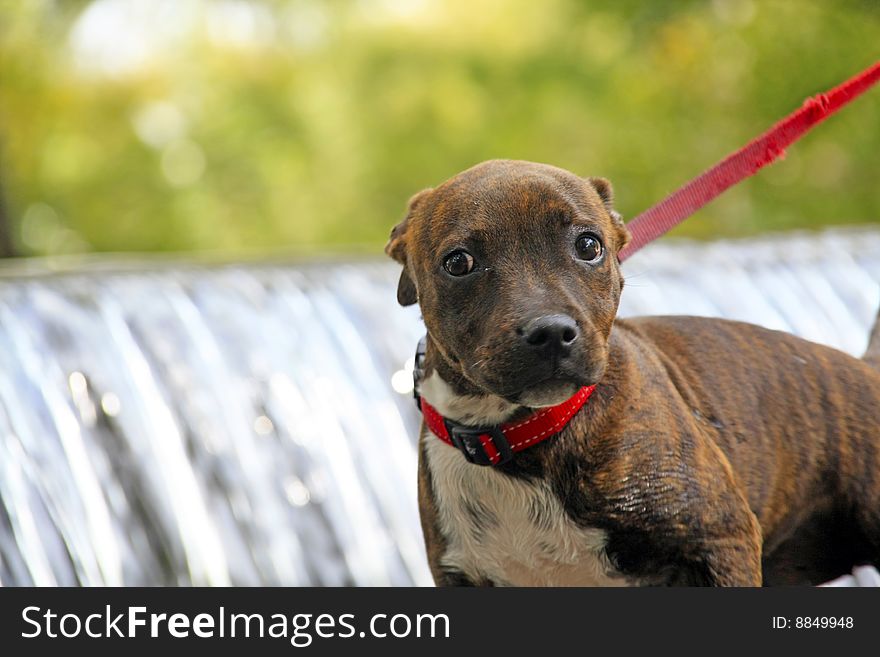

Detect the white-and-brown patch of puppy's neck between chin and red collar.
[{"left": 418, "top": 338, "right": 525, "bottom": 426}]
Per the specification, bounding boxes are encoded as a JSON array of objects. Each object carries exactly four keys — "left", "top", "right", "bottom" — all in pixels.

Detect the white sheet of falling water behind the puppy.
[{"left": 0, "top": 232, "right": 880, "bottom": 585}]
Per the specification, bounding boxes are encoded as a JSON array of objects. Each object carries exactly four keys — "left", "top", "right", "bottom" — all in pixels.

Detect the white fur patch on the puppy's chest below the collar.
[{"left": 426, "top": 435, "right": 628, "bottom": 586}]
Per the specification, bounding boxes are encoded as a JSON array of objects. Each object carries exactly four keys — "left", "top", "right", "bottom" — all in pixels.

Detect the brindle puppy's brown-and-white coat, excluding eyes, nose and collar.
[{"left": 386, "top": 161, "right": 880, "bottom": 585}]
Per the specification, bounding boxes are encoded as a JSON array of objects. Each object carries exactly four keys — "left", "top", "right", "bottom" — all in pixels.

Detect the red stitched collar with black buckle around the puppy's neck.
[{"left": 419, "top": 385, "right": 596, "bottom": 465}]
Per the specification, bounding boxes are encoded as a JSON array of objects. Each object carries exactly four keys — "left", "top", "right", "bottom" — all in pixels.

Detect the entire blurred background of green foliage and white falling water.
[{"left": 0, "top": 0, "right": 880, "bottom": 586}]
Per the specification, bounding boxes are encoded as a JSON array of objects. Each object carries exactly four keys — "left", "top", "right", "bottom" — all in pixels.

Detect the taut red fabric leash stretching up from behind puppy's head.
[{"left": 619, "top": 62, "right": 880, "bottom": 262}]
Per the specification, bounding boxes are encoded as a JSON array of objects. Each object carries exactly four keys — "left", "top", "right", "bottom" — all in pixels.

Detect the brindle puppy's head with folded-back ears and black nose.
[{"left": 385, "top": 160, "right": 629, "bottom": 407}]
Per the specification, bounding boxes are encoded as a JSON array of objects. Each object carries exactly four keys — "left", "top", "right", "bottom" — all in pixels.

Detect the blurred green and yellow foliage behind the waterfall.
[{"left": 0, "top": 0, "right": 880, "bottom": 254}]
